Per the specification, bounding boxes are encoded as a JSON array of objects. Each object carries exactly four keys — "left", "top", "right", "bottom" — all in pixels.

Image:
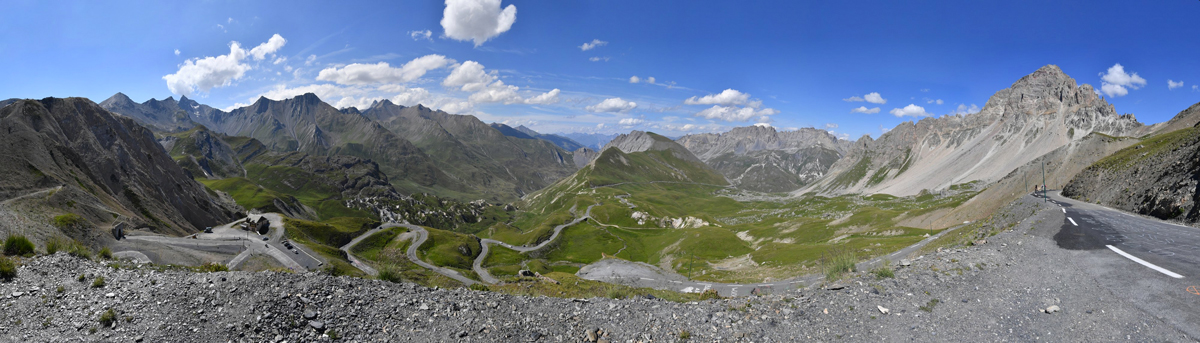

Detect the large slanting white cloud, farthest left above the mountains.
[{"left": 162, "top": 42, "right": 251, "bottom": 96}]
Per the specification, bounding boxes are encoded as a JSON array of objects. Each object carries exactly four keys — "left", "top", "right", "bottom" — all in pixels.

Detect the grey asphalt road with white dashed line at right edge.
[{"left": 1048, "top": 192, "right": 1200, "bottom": 337}]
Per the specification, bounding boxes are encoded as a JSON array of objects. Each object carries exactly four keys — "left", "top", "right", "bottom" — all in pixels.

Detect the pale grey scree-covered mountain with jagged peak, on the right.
[{"left": 798, "top": 65, "right": 1148, "bottom": 195}]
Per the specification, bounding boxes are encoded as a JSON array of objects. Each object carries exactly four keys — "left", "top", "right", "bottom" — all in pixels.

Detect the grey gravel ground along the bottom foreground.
[{"left": 0, "top": 196, "right": 1194, "bottom": 342}]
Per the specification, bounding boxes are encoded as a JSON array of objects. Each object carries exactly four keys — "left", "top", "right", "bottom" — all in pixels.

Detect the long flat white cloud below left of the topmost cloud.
[{"left": 317, "top": 55, "right": 454, "bottom": 85}]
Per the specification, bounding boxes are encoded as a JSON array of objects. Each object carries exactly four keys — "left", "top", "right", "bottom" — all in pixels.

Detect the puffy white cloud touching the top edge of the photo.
[{"left": 442, "top": 0, "right": 517, "bottom": 47}]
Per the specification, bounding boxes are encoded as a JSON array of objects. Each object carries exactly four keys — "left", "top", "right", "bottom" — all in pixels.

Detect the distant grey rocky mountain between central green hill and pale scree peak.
[{"left": 676, "top": 126, "right": 852, "bottom": 192}]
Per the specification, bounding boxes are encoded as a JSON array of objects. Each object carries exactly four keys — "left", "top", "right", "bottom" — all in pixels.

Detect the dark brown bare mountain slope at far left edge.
[{"left": 0, "top": 98, "right": 240, "bottom": 236}]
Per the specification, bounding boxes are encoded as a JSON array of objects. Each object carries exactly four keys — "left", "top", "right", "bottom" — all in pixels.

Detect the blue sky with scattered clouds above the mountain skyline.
[{"left": 0, "top": 0, "right": 1200, "bottom": 139}]
